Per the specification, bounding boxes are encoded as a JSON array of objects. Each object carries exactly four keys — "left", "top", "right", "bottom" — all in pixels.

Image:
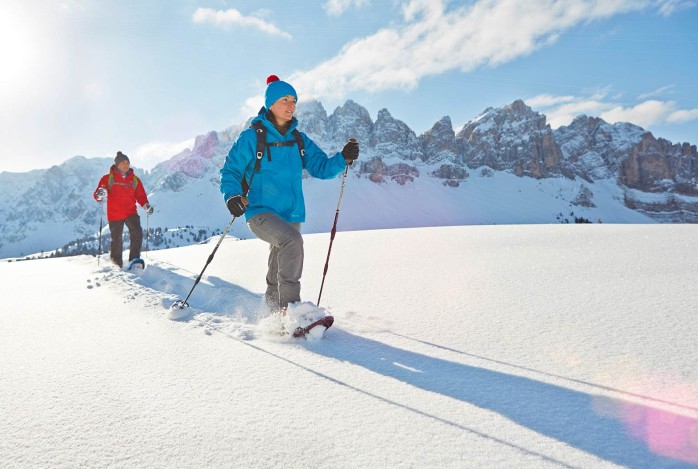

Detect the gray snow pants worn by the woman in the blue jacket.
[{"left": 247, "top": 212, "right": 303, "bottom": 310}]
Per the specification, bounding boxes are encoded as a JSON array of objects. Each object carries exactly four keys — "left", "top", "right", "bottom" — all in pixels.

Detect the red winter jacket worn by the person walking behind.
[{"left": 92, "top": 165, "right": 148, "bottom": 221}]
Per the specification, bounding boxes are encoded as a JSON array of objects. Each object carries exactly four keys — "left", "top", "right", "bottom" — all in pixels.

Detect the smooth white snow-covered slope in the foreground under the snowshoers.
[{"left": 0, "top": 225, "right": 698, "bottom": 468}]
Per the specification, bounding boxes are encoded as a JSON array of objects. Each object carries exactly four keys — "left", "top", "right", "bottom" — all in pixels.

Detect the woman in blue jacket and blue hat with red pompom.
[{"left": 221, "top": 75, "right": 359, "bottom": 314}]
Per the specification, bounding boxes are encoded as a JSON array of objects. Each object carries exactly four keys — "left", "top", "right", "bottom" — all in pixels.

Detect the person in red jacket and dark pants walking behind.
[{"left": 93, "top": 152, "right": 153, "bottom": 267}]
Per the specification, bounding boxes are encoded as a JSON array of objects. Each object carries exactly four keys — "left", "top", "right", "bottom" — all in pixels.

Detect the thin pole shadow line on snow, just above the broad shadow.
[{"left": 341, "top": 318, "right": 698, "bottom": 413}]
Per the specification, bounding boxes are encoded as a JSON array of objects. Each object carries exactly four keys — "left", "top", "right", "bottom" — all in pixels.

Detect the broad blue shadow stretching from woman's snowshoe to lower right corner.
[{"left": 313, "top": 329, "right": 698, "bottom": 468}]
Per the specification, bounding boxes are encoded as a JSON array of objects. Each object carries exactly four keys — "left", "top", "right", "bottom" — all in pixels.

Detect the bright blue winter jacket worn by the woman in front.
[{"left": 221, "top": 109, "right": 346, "bottom": 223}]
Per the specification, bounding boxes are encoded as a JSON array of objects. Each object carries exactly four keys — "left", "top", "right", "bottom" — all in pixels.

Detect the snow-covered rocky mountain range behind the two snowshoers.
[{"left": 0, "top": 100, "right": 698, "bottom": 258}]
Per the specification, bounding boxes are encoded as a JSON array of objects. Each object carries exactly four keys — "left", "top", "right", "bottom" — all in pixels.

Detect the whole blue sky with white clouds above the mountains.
[{"left": 0, "top": 0, "right": 698, "bottom": 171}]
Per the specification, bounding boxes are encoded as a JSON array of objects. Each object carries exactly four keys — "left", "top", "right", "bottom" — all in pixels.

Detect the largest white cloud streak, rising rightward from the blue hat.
[{"left": 290, "top": 0, "right": 654, "bottom": 99}]
